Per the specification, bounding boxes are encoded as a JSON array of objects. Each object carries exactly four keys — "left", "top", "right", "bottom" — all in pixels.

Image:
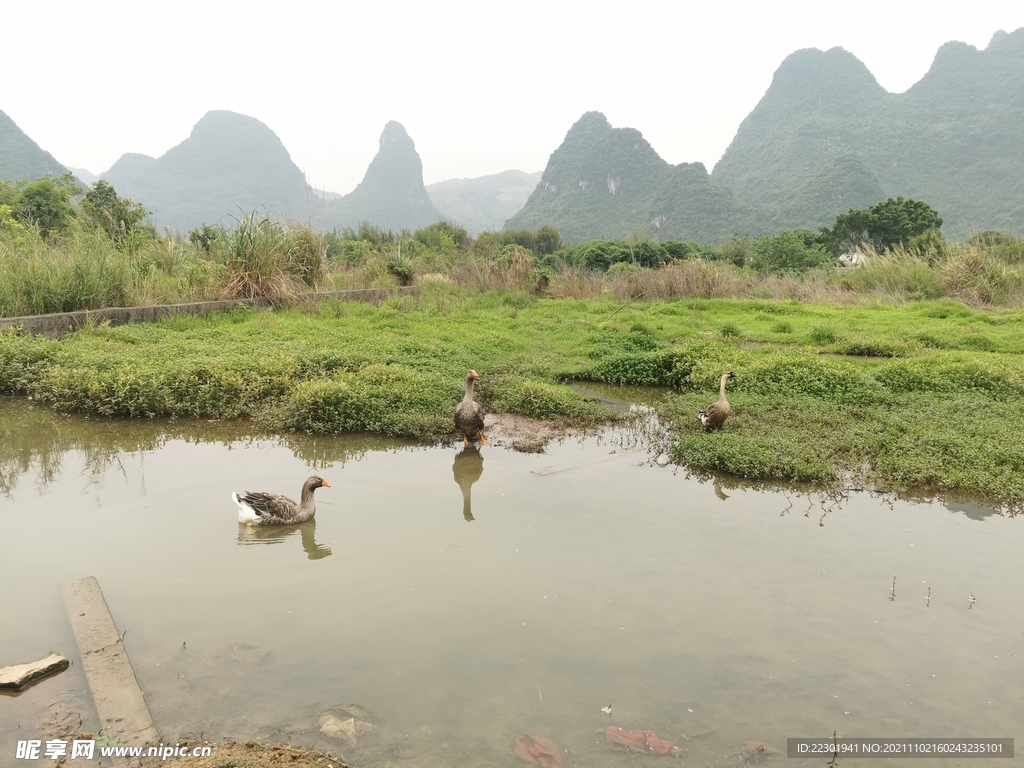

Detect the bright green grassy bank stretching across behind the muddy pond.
[{"left": 0, "top": 283, "right": 1024, "bottom": 503}]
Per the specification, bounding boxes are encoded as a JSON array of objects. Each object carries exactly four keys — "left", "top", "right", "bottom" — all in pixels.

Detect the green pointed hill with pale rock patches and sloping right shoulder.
[{"left": 506, "top": 112, "right": 763, "bottom": 243}]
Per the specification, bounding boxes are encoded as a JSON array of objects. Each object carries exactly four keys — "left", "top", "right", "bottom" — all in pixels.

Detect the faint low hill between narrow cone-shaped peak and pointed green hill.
[{"left": 427, "top": 171, "right": 541, "bottom": 236}]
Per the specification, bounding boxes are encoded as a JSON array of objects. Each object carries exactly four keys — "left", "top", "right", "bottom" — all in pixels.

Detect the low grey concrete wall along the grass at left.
[{"left": 0, "top": 286, "right": 420, "bottom": 339}]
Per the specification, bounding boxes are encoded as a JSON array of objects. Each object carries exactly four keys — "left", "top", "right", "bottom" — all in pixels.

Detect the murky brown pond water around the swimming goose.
[{"left": 0, "top": 400, "right": 1024, "bottom": 766}]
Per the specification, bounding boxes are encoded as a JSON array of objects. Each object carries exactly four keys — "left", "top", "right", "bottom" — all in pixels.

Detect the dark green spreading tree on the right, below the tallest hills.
[{"left": 821, "top": 198, "right": 942, "bottom": 256}]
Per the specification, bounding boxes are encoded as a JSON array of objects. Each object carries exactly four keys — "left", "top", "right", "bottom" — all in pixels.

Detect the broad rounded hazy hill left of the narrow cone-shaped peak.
[{"left": 103, "top": 111, "right": 310, "bottom": 229}]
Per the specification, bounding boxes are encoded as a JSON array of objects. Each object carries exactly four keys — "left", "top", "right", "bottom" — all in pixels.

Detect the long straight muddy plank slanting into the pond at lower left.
[{"left": 60, "top": 577, "right": 160, "bottom": 746}]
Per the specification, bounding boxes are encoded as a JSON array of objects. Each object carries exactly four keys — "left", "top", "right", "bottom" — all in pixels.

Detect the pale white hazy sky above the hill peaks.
[{"left": 8, "top": 0, "right": 1024, "bottom": 193}]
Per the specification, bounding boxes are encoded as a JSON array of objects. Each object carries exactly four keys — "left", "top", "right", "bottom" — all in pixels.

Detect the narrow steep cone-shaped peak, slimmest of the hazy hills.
[{"left": 323, "top": 121, "right": 441, "bottom": 230}]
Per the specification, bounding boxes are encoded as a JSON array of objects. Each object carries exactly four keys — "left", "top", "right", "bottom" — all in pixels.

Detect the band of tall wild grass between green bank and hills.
[{"left": 0, "top": 213, "right": 1024, "bottom": 315}]
